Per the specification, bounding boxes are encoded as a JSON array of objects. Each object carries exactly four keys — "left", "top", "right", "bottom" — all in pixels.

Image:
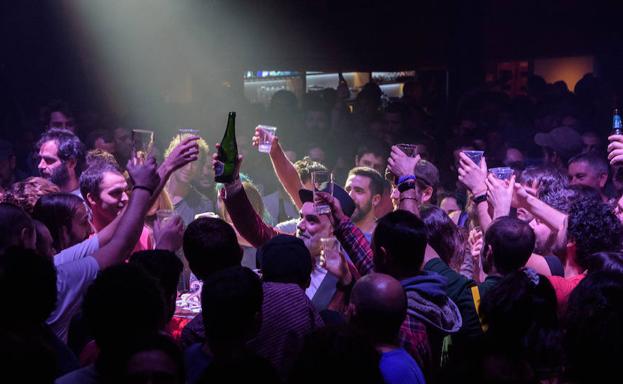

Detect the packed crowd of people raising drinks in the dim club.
[{"left": 0, "top": 75, "right": 623, "bottom": 384}]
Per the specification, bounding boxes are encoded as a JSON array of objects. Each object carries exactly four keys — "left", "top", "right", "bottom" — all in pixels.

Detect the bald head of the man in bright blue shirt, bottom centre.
[{"left": 350, "top": 273, "right": 407, "bottom": 343}]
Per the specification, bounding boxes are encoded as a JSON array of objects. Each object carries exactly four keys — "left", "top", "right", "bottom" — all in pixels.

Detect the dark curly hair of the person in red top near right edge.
[{"left": 567, "top": 199, "right": 623, "bottom": 269}]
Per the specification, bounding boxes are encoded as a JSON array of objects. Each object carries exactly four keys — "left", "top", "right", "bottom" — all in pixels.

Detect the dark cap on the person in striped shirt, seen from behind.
[{"left": 256, "top": 235, "right": 312, "bottom": 284}]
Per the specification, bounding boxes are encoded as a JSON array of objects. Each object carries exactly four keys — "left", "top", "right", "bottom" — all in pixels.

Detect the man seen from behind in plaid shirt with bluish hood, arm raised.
[{"left": 322, "top": 194, "right": 462, "bottom": 377}]
